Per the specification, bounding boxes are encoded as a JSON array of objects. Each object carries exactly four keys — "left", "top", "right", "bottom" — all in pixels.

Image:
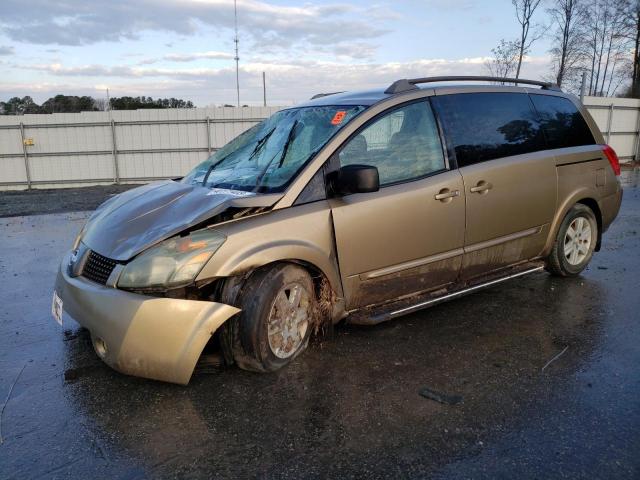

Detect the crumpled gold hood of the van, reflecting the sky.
[{"left": 82, "top": 180, "right": 282, "bottom": 261}]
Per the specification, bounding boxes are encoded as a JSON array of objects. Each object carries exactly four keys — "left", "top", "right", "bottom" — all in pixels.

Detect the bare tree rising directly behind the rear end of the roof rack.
[{"left": 547, "top": 0, "right": 588, "bottom": 86}]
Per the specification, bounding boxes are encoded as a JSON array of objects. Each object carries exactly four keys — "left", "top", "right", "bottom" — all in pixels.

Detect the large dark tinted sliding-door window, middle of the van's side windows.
[{"left": 432, "top": 93, "right": 547, "bottom": 167}]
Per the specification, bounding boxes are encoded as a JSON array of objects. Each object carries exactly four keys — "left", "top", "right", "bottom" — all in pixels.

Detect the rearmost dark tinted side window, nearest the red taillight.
[{"left": 531, "top": 95, "right": 596, "bottom": 148}]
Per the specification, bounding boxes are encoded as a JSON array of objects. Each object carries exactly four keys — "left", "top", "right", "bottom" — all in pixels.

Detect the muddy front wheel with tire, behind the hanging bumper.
[{"left": 221, "top": 264, "right": 318, "bottom": 372}]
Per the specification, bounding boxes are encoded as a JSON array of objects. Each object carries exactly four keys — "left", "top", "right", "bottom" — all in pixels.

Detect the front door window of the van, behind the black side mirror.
[{"left": 339, "top": 101, "right": 446, "bottom": 186}]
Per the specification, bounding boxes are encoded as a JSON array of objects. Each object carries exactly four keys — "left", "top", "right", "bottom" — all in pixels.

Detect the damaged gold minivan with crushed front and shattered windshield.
[{"left": 52, "top": 77, "right": 622, "bottom": 384}]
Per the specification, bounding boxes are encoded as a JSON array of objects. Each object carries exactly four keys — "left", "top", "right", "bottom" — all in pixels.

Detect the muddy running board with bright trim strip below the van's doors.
[{"left": 347, "top": 265, "right": 544, "bottom": 325}]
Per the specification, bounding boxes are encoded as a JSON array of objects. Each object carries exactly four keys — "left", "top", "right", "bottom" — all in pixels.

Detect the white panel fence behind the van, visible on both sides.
[{"left": 0, "top": 97, "right": 640, "bottom": 190}]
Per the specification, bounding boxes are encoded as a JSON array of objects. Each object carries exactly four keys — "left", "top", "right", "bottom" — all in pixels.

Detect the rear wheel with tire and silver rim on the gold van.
[{"left": 546, "top": 203, "right": 598, "bottom": 277}]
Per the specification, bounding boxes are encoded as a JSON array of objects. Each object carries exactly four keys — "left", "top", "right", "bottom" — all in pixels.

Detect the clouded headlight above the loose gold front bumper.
[{"left": 118, "top": 230, "right": 227, "bottom": 288}]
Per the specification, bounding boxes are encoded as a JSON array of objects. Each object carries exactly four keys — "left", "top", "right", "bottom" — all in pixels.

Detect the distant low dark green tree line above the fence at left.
[{"left": 0, "top": 95, "right": 194, "bottom": 115}]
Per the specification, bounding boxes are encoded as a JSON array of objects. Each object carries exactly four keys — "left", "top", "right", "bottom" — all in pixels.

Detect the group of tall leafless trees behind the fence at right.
[{"left": 485, "top": 0, "right": 640, "bottom": 98}]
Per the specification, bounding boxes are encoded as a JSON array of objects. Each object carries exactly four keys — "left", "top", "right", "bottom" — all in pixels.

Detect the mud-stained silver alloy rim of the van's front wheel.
[{"left": 267, "top": 282, "right": 311, "bottom": 358}]
